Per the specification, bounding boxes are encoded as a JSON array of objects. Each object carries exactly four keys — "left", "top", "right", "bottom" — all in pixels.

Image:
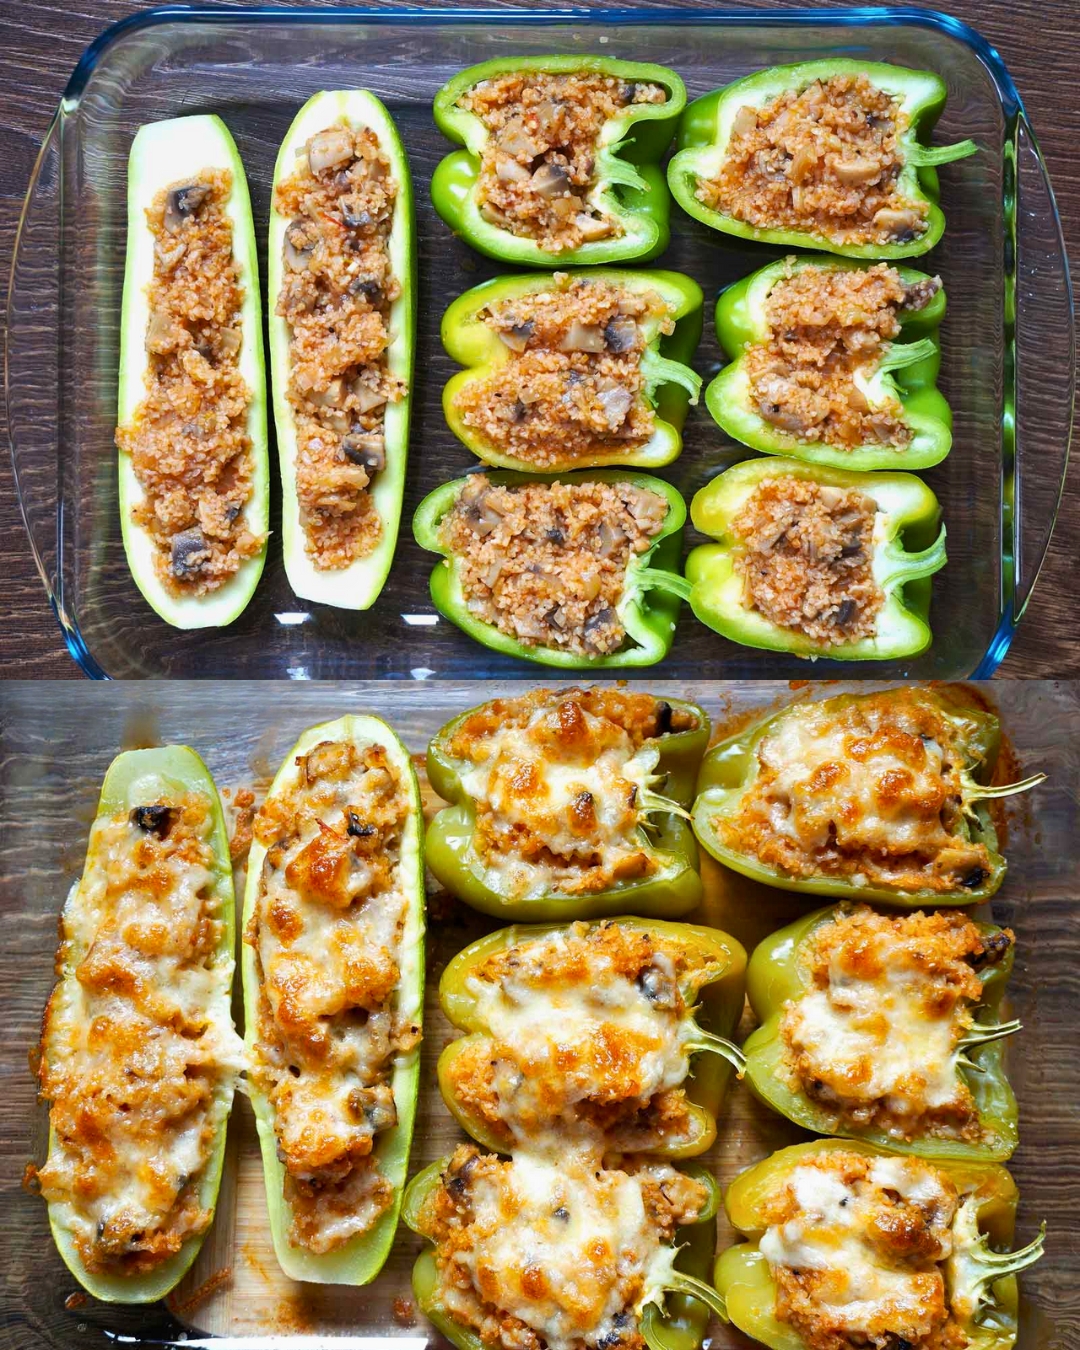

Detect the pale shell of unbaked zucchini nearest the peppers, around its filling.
[{"left": 266, "top": 89, "right": 416, "bottom": 609}]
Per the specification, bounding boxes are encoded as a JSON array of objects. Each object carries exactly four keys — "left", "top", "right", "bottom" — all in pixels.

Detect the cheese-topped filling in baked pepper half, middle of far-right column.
[{"left": 780, "top": 905, "right": 1013, "bottom": 1142}]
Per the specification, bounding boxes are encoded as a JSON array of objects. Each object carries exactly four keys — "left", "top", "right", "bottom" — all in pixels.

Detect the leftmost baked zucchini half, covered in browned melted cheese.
[{"left": 38, "top": 745, "right": 243, "bottom": 1303}]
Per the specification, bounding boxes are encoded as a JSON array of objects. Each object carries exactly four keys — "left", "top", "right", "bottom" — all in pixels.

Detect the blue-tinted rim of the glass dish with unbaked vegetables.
[{"left": 29, "top": 4, "right": 1072, "bottom": 679}]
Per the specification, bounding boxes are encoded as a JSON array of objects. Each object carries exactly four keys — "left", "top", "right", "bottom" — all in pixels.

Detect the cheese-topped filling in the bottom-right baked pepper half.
[{"left": 760, "top": 1150, "right": 973, "bottom": 1350}]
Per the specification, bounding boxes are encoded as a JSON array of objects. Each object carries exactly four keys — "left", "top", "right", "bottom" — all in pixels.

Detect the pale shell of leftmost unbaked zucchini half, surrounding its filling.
[{"left": 116, "top": 116, "right": 270, "bottom": 628}]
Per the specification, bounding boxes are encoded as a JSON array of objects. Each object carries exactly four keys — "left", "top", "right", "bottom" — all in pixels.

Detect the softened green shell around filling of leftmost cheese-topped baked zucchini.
[{"left": 42, "top": 745, "right": 239, "bottom": 1303}]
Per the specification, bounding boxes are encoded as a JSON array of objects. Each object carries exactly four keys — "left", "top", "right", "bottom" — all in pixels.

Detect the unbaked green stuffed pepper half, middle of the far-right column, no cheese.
[{"left": 705, "top": 258, "right": 952, "bottom": 470}]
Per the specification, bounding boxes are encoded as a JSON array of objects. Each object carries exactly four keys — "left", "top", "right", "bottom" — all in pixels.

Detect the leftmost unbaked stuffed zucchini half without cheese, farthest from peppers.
[{"left": 116, "top": 116, "right": 269, "bottom": 628}]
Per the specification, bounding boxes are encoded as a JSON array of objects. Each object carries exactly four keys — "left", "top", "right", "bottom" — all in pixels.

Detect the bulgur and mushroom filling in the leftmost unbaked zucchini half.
[{"left": 116, "top": 169, "right": 266, "bottom": 597}]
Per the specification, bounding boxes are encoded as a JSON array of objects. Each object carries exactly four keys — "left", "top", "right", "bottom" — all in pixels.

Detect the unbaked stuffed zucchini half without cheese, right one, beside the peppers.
[{"left": 267, "top": 89, "right": 416, "bottom": 609}]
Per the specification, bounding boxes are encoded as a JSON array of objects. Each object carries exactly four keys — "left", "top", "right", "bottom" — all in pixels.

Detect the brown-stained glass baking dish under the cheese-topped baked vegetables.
[{"left": 0, "top": 680, "right": 1080, "bottom": 1350}]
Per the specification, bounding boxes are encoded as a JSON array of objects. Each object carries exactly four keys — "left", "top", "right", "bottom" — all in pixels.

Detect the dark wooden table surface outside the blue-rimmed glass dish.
[{"left": 0, "top": 0, "right": 1080, "bottom": 679}]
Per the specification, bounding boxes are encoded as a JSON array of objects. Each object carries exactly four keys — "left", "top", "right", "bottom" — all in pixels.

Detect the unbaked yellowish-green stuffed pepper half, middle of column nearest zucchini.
[{"left": 441, "top": 269, "right": 702, "bottom": 473}]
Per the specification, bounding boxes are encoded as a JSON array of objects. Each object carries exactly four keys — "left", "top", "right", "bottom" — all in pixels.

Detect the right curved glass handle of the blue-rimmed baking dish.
[{"left": 1002, "top": 109, "right": 1076, "bottom": 624}]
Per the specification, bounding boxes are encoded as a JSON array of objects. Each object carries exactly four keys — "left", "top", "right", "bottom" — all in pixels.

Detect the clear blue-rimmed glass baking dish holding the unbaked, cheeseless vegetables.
[{"left": 5, "top": 7, "right": 1073, "bottom": 679}]
